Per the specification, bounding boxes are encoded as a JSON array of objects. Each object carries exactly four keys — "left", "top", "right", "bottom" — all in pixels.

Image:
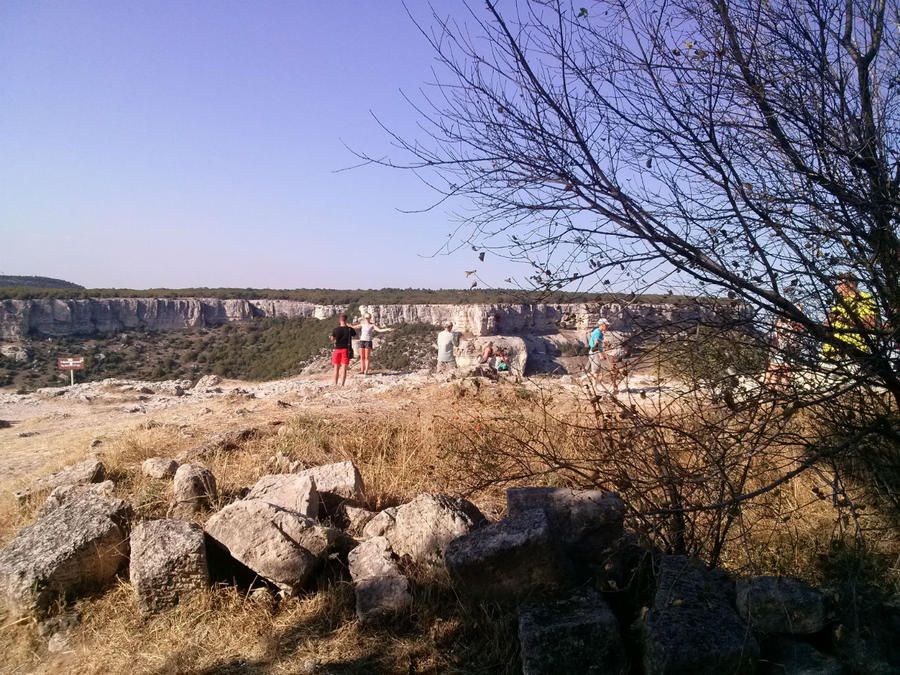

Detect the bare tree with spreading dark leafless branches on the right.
[{"left": 362, "top": 0, "right": 900, "bottom": 544}]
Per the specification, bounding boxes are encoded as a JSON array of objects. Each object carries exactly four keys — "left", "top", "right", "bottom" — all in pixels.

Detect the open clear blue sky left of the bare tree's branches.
[{"left": 0, "top": 0, "right": 530, "bottom": 288}]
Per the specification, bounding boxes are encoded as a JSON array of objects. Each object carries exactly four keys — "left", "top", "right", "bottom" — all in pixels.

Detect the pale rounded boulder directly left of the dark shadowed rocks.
[{"left": 386, "top": 492, "right": 486, "bottom": 562}]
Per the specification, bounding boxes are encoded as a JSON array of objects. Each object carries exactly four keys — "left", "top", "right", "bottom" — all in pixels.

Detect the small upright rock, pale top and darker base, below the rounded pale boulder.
[{"left": 347, "top": 537, "right": 412, "bottom": 623}]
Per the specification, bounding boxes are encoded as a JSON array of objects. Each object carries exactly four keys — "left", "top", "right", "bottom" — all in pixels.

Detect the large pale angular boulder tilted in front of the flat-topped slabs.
[{"left": 205, "top": 499, "right": 337, "bottom": 595}]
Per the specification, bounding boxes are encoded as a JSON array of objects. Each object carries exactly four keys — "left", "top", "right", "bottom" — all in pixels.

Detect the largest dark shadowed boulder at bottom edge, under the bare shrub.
[{"left": 643, "top": 555, "right": 759, "bottom": 675}]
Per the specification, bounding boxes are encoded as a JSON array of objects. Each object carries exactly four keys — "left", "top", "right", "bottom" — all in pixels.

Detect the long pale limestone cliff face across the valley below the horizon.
[{"left": 0, "top": 298, "right": 708, "bottom": 340}]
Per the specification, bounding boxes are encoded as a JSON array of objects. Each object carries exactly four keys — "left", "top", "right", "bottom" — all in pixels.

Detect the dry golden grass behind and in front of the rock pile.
[{"left": 0, "top": 384, "right": 900, "bottom": 674}]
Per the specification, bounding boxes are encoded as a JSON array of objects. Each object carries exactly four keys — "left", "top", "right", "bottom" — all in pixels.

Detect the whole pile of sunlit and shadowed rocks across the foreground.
[{"left": 0, "top": 458, "right": 900, "bottom": 675}]
